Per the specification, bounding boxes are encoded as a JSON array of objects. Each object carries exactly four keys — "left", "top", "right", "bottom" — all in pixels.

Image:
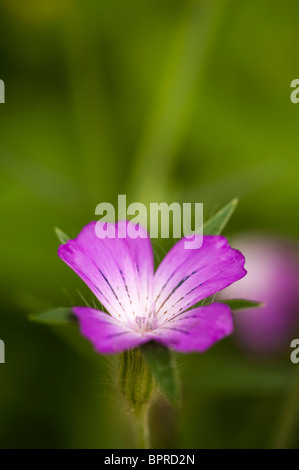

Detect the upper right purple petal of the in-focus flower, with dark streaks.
[{"left": 154, "top": 236, "right": 246, "bottom": 323}]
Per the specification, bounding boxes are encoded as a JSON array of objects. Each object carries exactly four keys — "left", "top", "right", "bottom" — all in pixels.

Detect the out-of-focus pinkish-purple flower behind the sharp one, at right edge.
[{"left": 217, "top": 235, "right": 299, "bottom": 355}]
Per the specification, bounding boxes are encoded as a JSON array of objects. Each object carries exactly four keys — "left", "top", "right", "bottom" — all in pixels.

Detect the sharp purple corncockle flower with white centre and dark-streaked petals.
[{"left": 58, "top": 221, "right": 246, "bottom": 354}]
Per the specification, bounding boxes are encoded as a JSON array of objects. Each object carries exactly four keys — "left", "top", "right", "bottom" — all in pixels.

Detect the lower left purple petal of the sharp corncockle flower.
[{"left": 73, "top": 307, "right": 149, "bottom": 354}]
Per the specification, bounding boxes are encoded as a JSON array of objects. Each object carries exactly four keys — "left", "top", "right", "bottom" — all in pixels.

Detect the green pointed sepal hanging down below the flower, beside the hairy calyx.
[{"left": 140, "top": 341, "right": 180, "bottom": 405}]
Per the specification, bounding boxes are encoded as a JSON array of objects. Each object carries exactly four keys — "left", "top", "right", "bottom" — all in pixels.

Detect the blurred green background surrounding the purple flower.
[{"left": 0, "top": 0, "right": 299, "bottom": 449}]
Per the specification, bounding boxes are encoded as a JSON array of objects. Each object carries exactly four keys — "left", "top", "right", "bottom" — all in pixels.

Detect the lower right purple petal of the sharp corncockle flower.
[{"left": 153, "top": 303, "right": 233, "bottom": 353}]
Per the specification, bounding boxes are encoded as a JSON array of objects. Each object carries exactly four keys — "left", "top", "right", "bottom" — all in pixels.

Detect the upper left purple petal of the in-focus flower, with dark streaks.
[{"left": 58, "top": 221, "right": 153, "bottom": 326}]
